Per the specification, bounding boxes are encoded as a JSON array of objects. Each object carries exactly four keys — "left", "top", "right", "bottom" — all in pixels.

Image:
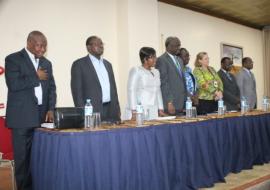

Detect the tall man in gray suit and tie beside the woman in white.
[{"left": 156, "top": 37, "right": 187, "bottom": 115}]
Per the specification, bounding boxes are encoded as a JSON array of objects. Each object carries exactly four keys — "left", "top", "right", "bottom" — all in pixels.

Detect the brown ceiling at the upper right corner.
[{"left": 158, "top": 0, "right": 270, "bottom": 30}]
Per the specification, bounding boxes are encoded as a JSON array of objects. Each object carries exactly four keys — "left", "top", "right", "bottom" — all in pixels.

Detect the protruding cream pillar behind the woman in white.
[{"left": 118, "top": 0, "right": 159, "bottom": 115}]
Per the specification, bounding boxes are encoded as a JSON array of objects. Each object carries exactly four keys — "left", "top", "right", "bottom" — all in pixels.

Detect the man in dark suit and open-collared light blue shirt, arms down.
[{"left": 71, "top": 36, "right": 120, "bottom": 122}]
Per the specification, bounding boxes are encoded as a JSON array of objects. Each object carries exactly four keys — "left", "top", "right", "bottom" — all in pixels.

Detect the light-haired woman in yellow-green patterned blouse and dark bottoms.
[{"left": 193, "top": 52, "right": 223, "bottom": 114}]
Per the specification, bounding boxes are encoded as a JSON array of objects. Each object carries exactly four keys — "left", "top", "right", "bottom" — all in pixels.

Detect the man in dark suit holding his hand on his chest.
[{"left": 5, "top": 31, "right": 56, "bottom": 190}]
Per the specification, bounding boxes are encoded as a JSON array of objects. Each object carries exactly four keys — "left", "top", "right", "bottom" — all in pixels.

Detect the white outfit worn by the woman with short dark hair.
[{"left": 124, "top": 66, "right": 163, "bottom": 119}]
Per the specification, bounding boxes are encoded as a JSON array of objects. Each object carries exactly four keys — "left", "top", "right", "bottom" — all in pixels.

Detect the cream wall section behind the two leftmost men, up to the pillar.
[{"left": 0, "top": 0, "right": 119, "bottom": 115}]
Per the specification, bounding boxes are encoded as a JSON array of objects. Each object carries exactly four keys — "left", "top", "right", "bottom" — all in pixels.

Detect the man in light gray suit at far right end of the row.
[{"left": 236, "top": 57, "right": 257, "bottom": 109}]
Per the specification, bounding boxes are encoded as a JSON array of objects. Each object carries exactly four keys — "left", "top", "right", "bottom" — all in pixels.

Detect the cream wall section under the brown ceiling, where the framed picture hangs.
[{"left": 158, "top": 3, "right": 264, "bottom": 107}]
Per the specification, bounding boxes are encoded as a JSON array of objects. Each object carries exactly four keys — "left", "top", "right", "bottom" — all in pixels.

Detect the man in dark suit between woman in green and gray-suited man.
[{"left": 218, "top": 57, "right": 240, "bottom": 111}]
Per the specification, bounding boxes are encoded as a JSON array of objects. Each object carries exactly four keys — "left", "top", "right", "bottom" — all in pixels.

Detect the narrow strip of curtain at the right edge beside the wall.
[{"left": 263, "top": 26, "right": 270, "bottom": 96}]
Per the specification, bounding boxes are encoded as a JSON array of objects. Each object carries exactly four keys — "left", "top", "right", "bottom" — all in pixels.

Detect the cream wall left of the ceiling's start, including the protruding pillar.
[{"left": 0, "top": 0, "right": 158, "bottom": 115}]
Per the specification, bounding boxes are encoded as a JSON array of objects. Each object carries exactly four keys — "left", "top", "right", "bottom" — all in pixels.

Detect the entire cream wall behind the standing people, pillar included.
[{"left": 0, "top": 0, "right": 263, "bottom": 115}]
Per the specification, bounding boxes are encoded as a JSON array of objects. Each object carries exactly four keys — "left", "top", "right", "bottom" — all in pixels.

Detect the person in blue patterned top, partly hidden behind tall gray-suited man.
[{"left": 177, "top": 48, "right": 199, "bottom": 106}]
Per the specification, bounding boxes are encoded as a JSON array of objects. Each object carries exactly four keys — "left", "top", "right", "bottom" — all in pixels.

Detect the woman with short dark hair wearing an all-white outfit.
[{"left": 126, "top": 47, "right": 165, "bottom": 120}]
